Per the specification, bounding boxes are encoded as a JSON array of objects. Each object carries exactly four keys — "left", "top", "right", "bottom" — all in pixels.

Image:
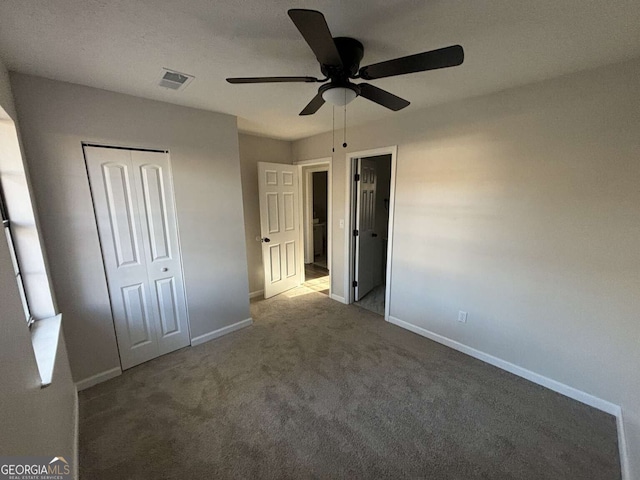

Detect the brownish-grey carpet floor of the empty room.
[{"left": 80, "top": 287, "right": 620, "bottom": 480}]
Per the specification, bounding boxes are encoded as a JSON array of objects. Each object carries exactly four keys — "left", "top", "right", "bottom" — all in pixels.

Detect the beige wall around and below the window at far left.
[{"left": 0, "top": 58, "right": 76, "bottom": 470}]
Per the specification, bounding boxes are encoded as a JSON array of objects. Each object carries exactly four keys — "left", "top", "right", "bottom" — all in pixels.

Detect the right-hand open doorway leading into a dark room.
[{"left": 345, "top": 147, "right": 396, "bottom": 319}]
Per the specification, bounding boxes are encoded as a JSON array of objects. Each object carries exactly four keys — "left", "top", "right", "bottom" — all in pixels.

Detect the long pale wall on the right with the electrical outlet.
[{"left": 293, "top": 60, "right": 640, "bottom": 478}]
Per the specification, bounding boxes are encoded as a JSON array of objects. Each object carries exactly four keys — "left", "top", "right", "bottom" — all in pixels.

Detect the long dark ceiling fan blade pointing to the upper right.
[{"left": 360, "top": 45, "right": 464, "bottom": 80}]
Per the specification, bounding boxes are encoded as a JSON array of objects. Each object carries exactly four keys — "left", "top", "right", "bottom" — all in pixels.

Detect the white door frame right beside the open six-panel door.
[{"left": 293, "top": 157, "right": 333, "bottom": 292}]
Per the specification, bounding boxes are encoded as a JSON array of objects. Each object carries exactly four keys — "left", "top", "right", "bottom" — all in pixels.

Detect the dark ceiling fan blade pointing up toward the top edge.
[{"left": 288, "top": 8, "right": 342, "bottom": 67}]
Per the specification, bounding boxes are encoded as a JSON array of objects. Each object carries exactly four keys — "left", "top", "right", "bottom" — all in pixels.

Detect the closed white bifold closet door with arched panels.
[{"left": 84, "top": 147, "right": 190, "bottom": 369}]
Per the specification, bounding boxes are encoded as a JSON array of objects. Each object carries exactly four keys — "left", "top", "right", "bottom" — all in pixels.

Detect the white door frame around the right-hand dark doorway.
[{"left": 344, "top": 145, "right": 398, "bottom": 321}]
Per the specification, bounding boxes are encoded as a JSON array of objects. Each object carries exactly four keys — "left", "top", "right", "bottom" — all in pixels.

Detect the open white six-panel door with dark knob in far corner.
[{"left": 258, "top": 162, "right": 302, "bottom": 298}]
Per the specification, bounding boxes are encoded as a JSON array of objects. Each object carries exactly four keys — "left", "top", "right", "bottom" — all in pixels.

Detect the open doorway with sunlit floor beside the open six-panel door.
[{"left": 299, "top": 160, "right": 331, "bottom": 295}]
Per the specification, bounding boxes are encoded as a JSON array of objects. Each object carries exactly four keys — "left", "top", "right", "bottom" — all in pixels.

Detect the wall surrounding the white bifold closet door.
[{"left": 11, "top": 74, "right": 249, "bottom": 381}]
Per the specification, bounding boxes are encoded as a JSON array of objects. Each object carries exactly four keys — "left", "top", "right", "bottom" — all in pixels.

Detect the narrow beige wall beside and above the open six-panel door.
[{"left": 238, "top": 133, "right": 292, "bottom": 292}]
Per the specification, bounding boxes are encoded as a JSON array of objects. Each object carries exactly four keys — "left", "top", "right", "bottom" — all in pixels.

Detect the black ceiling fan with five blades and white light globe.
[{"left": 227, "top": 8, "right": 464, "bottom": 115}]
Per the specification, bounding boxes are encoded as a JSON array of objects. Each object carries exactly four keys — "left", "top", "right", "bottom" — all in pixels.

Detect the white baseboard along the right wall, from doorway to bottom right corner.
[{"left": 389, "top": 316, "right": 631, "bottom": 480}]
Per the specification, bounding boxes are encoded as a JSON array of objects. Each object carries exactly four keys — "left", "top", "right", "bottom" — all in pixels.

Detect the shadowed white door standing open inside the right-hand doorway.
[{"left": 355, "top": 158, "right": 378, "bottom": 301}]
